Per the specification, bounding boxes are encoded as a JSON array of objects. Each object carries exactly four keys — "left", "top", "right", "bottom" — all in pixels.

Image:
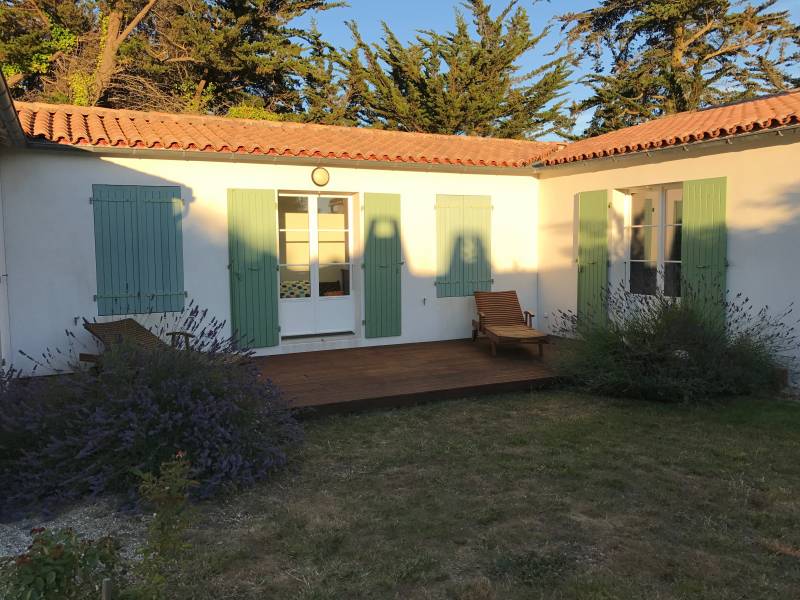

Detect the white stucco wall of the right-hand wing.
[{"left": 538, "top": 132, "right": 800, "bottom": 376}]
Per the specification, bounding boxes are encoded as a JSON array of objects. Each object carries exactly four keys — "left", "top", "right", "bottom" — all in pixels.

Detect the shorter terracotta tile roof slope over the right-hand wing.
[{"left": 543, "top": 90, "right": 800, "bottom": 165}]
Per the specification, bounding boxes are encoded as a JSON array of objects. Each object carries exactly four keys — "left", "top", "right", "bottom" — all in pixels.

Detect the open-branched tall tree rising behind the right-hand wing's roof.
[{"left": 560, "top": 0, "right": 800, "bottom": 135}]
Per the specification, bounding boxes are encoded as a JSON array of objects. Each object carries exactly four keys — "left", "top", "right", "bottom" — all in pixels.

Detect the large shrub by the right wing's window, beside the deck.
[{"left": 557, "top": 288, "right": 798, "bottom": 402}]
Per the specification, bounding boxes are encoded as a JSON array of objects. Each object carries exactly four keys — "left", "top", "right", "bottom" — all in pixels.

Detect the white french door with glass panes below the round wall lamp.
[{"left": 278, "top": 194, "right": 356, "bottom": 337}]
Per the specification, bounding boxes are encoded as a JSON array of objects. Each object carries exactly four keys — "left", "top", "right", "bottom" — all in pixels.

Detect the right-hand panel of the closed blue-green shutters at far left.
[{"left": 137, "top": 186, "right": 186, "bottom": 312}]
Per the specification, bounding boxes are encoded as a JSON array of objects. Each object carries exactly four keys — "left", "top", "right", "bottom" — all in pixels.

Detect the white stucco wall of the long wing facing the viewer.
[{"left": 2, "top": 150, "right": 539, "bottom": 370}]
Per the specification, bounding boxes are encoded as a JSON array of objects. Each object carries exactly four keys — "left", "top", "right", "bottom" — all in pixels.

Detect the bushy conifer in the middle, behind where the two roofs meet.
[{"left": 345, "top": 0, "right": 572, "bottom": 138}]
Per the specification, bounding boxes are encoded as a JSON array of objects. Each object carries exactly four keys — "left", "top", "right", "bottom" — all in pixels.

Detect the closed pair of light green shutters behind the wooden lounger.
[{"left": 436, "top": 195, "right": 492, "bottom": 298}]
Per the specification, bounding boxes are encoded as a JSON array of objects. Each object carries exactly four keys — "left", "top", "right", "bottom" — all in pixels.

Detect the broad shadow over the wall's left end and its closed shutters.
[{"left": 3, "top": 151, "right": 200, "bottom": 372}]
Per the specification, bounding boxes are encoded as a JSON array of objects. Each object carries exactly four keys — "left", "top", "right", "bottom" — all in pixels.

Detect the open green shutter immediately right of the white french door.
[{"left": 364, "top": 194, "right": 403, "bottom": 338}]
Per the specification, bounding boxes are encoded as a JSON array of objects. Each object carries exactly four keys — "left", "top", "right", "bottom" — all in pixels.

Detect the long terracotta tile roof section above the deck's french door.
[{"left": 16, "top": 102, "right": 558, "bottom": 167}]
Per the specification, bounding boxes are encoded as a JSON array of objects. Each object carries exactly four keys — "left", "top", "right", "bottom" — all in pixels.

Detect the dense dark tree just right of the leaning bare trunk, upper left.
[{"left": 120, "top": 0, "right": 341, "bottom": 114}]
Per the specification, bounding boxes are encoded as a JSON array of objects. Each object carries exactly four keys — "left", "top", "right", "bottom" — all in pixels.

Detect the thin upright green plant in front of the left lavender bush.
[{"left": 123, "top": 452, "right": 197, "bottom": 600}]
